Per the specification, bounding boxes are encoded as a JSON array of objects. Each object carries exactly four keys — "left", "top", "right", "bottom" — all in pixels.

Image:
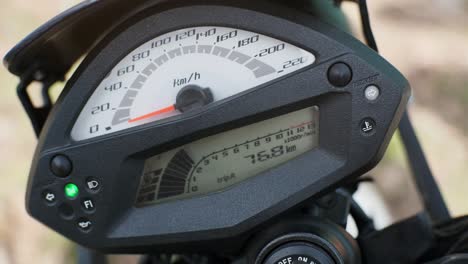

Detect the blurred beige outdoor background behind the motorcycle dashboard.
[{"left": 0, "top": 0, "right": 468, "bottom": 264}]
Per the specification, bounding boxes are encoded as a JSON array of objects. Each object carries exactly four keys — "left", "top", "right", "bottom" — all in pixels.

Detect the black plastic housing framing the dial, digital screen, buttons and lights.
[{"left": 27, "top": 1, "right": 410, "bottom": 254}]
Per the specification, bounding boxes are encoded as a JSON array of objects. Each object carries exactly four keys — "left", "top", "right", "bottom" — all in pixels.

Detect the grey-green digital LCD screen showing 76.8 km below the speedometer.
[{"left": 136, "top": 107, "right": 319, "bottom": 206}]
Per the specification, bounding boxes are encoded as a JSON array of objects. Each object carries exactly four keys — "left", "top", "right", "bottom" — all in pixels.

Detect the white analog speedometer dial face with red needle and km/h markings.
[{"left": 71, "top": 27, "right": 315, "bottom": 141}]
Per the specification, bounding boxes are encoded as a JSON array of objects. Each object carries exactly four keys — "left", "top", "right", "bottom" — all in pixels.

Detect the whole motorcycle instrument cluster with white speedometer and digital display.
[{"left": 23, "top": 1, "right": 409, "bottom": 252}]
